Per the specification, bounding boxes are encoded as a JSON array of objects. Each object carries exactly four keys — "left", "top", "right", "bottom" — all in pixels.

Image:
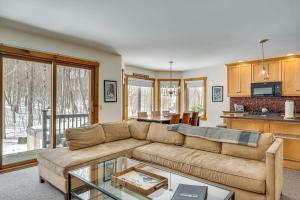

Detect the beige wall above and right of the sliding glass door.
[{"left": 0, "top": 25, "right": 122, "bottom": 122}]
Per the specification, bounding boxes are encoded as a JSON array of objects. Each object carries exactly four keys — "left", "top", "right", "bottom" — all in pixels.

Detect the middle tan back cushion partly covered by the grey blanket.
[{"left": 184, "top": 136, "right": 222, "bottom": 153}]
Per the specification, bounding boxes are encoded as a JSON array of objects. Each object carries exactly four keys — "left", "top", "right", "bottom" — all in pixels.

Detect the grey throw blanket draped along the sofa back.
[{"left": 168, "top": 124, "right": 260, "bottom": 147}]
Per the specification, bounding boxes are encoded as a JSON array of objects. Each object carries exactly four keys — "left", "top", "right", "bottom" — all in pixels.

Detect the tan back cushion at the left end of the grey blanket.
[{"left": 147, "top": 123, "right": 184, "bottom": 145}]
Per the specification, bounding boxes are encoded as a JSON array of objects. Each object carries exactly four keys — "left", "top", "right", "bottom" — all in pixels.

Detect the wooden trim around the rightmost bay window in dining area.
[{"left": 183, "top": 77, "right": 207, "bottom": 120}]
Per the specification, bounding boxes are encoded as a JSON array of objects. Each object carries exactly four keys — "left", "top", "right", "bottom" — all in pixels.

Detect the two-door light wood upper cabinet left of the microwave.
[{"left": 227, "top": 64, "right": 251, "bottom": 97}]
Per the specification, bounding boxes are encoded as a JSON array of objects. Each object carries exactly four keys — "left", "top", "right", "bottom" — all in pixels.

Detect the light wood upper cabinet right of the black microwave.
[{"left": 282, "top": 58, "right": 300, "bottom": 96}]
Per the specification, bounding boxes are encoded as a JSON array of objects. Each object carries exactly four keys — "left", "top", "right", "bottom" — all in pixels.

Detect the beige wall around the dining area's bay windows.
[{"left": 125, "top": 66, "right": 229, "bottom": 126}]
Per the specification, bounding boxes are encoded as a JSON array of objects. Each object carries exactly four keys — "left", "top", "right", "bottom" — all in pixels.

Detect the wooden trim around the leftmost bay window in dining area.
[{"left": 122, "top": 74, "right": 155, "bottom": 120}]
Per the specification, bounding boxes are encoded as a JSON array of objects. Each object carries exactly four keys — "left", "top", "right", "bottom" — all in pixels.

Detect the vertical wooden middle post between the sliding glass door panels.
[{"left": 51, "top": 62, "right": 57, "bottom": 149}]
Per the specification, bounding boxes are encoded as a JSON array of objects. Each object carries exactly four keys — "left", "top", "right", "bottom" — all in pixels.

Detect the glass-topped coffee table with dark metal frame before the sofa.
[{"left": 68, "top": 157, "right": 234, "bottom": 200}]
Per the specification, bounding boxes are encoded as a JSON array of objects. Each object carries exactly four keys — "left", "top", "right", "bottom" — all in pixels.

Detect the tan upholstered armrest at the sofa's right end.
[{"left": 266, "top": 138, "right": 283, "bottom": 200}]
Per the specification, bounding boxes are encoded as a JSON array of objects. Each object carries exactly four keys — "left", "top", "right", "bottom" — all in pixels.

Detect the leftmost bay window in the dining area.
[{"left": 126, "top": 76, "right": 154, "bottom": 117}]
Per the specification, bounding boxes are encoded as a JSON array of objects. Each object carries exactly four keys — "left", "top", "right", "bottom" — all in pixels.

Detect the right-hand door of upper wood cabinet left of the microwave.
[{"left": 238, "top": 64, "right": 251, "bottom": 97}]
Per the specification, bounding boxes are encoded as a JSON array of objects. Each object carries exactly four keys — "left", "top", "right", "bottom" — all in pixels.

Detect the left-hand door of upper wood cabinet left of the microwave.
[{"left": 227, "top": 65, "right": 240, "bottom": 97}]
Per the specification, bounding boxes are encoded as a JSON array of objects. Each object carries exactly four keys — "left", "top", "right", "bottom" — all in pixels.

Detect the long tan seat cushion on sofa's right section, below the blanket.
[{"left": 133, "top": 143, "right": 266, "bottom": 194}]
